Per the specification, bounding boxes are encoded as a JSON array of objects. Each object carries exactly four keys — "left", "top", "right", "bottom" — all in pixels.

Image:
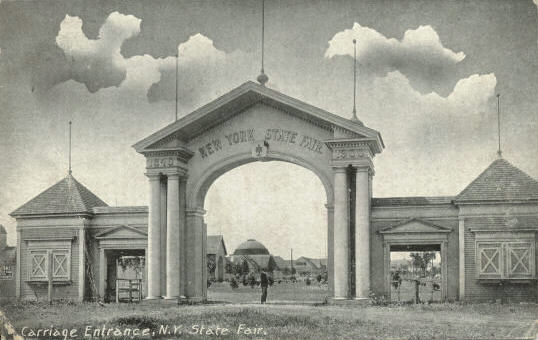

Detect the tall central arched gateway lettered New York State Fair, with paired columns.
[{"left": 134, "top": 82, "right": 384, "bottom": 300}]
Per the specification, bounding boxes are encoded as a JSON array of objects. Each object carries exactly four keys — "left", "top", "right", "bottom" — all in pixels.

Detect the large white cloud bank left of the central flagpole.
[{"left": 56, "top": 12, "right": 255, "bottom": 110}]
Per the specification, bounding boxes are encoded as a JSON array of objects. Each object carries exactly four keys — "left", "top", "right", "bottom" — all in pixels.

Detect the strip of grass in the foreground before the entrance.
[{"left": 1, "top": 298, "right": 538, "bottom": 339}]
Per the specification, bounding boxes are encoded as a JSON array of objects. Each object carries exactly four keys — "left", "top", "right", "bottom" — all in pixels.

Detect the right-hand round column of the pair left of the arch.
[{"left": 165, "top": 174, "right": 181, "bottom": 299}]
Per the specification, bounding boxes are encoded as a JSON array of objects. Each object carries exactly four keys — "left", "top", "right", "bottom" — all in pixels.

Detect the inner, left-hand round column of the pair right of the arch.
[{"left": 334, "top": 167, "right": 349, "bottom": 299}]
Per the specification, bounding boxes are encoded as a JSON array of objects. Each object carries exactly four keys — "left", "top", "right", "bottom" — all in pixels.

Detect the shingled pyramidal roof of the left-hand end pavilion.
[{"left": 10, "top": 174, "right": 108, "bottom": 217}]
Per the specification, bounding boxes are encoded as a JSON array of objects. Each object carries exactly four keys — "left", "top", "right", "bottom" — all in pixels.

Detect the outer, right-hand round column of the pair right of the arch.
[{"left": 355, "top": 167, "right": 370, "bottom": 299}]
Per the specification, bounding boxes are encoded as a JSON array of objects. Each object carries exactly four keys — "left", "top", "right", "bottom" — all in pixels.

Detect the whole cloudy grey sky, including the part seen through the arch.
[{"left": 0, "top": 0, "right": 538, "bottom": 257}]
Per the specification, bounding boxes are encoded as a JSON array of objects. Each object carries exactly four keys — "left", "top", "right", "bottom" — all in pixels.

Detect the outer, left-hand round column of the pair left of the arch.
[{"left": 146, "top": 174, "right": 161, "bottom": 299}]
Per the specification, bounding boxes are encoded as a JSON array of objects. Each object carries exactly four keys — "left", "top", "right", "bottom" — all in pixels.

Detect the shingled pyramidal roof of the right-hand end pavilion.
[{"left": 455, "top": 158, "right": 538, "bottom": 202}]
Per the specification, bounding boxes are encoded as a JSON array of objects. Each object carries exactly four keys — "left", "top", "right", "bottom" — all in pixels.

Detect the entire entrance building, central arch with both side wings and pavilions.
[{"left": 11, "top": 82, "right": 538, "bottom": 302}]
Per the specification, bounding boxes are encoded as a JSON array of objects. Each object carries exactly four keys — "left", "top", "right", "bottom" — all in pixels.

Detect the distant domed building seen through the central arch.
[{"left": 229, "top": 239, "right": 278, "bottom": 273}]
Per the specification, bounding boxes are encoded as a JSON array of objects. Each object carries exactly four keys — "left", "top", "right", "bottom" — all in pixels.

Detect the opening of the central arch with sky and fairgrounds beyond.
[{"left": 202, "top": 161, "right": 330, "bottom": 302}]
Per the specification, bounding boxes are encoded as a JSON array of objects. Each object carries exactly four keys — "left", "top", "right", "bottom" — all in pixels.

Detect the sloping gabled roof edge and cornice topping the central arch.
[{"left": 133, "top": 81, "right": 384, "bottom": 153}]
